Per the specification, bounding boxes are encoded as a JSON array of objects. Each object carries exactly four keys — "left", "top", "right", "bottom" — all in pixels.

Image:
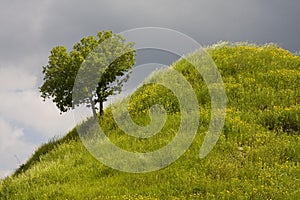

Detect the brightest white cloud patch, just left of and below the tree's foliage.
[{"left": 0, "top": 90, "right": 74, "bottom": 137}]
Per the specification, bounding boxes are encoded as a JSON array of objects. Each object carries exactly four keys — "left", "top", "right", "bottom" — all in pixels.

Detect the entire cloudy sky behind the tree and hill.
[{"left": 0, "top": 0, "right": 300, "bottom": 177}]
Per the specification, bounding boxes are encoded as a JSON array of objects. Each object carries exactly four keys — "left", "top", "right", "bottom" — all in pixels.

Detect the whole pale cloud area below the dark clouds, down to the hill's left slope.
[{"left": 0, "top": 68, "right": 75, "bottom": 177}]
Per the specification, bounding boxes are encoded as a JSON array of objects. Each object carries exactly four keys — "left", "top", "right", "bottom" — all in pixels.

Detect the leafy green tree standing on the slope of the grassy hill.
[{"left": 40, "top": 31, "right": 135, "bottom": 117}]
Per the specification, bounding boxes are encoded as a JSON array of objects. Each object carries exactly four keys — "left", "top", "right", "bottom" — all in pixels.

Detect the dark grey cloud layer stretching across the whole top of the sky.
[{"left": 0, "top": 0, "right": 300, "bottom": 71}]
